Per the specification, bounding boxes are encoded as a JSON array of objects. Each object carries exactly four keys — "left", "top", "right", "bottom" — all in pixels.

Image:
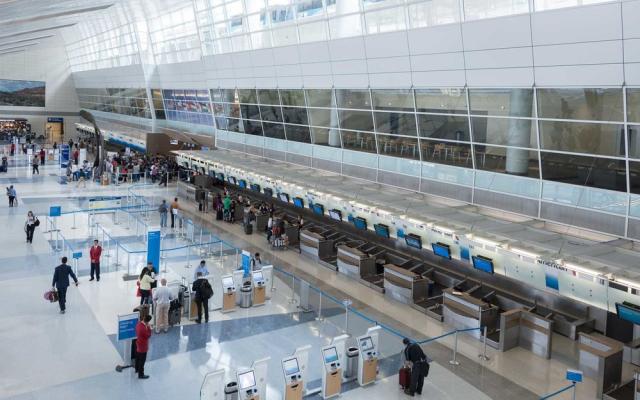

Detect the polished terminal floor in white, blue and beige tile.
[{"left": 0, "top": 166, "right": 628, "bottom": 400}]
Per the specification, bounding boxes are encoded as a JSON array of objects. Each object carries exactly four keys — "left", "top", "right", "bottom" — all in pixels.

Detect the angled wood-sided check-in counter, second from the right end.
[{"left": 498, "top": 308, "right": 553, "bottom": 359}]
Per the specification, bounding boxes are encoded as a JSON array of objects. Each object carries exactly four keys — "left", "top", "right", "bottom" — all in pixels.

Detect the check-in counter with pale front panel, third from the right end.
[{"left": 442, "top": 288, "right": 498, "bottom": 338}]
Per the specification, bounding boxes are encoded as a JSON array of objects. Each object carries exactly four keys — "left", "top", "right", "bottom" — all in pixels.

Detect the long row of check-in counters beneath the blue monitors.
[{"left": 179, "top": 177, "right": 636, "bottom": 399}]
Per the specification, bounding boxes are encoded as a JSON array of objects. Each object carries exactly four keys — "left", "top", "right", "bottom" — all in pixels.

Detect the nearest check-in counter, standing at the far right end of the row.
[{"left": 578, "top": 332, "right": 624, "bottom": 398}]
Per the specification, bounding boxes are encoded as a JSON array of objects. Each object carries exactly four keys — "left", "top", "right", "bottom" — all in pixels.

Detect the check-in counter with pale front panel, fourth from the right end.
[{"left": 384, "top": 264, "right": 430, "bottom": 304}]
